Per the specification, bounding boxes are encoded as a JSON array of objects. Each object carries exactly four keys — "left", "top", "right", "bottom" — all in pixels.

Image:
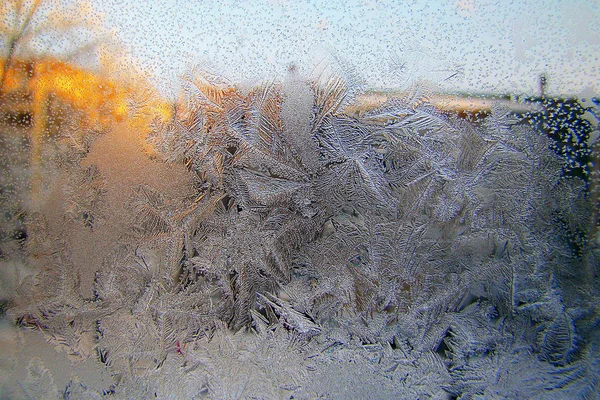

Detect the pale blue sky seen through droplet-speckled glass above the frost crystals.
[{"left": 92, "top": 0, "right": 600, "bottom": 96}]
